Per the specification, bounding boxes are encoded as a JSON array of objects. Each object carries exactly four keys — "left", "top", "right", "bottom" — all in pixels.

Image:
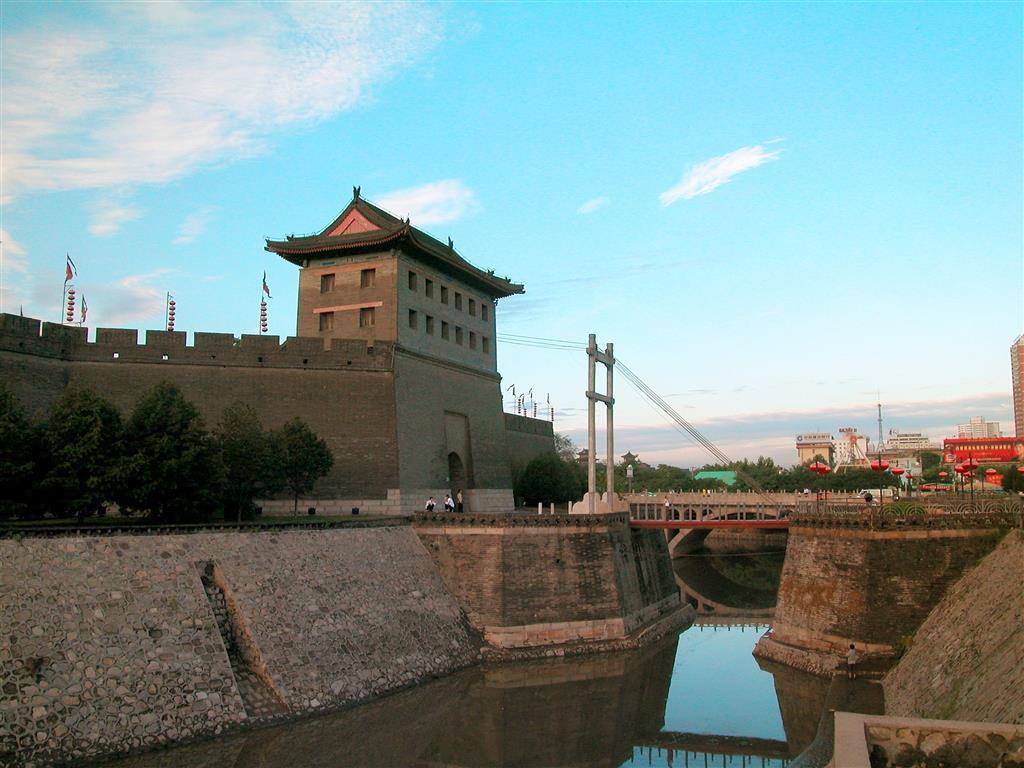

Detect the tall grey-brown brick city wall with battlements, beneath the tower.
[{"left": 0, "top": 314, "right": 553, "bottom": 514}]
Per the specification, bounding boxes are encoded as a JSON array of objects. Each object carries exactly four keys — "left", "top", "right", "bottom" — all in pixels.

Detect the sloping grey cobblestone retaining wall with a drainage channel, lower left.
[{"left": 0, "top": 526, "right": 479, "bottom": 765}]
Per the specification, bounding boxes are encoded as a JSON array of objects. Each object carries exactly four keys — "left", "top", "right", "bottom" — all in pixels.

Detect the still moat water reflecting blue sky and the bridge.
[{"left": 92, "top": 547, "right": 802, "bottom": 768}]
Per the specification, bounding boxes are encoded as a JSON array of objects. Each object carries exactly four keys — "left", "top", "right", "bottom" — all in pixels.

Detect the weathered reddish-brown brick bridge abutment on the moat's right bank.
[{"left": 755, "top": 515, "right": 1006, "bottom": 674}]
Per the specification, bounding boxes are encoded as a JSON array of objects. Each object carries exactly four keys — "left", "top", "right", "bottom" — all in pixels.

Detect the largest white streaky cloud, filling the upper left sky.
[{"left": 0, "top": 2, "right": 439, "bottom": 199}]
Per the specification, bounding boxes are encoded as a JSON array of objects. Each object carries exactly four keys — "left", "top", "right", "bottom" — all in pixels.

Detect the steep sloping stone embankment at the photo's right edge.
[{"left": 884, "top": 530, "right": 1024, "bottom": 724}]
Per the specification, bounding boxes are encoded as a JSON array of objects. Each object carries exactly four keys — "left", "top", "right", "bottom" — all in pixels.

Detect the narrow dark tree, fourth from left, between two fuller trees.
[{"left": 215, "top": 402, "right": 281, "bottom": 520}]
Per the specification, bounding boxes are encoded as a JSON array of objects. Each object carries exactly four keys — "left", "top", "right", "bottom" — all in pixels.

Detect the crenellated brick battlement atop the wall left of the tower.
[{"left": 0, "top": 313, "right": 394, "bottom": 371}]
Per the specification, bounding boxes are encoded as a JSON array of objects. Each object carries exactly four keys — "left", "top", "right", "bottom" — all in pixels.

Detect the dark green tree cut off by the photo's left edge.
[{"left": 0, "top": 384, "right": 46, "bottom": 519}]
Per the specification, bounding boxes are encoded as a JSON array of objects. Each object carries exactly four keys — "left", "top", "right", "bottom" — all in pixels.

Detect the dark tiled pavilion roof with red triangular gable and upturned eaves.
[{"left": 265, "top": 187, "right": 524, "bottom": 298}]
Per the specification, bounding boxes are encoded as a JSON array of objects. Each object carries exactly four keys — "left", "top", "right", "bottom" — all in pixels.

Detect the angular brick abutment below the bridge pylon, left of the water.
[{"left": 414, "top": 514, "right": 693, "bottom": 657}]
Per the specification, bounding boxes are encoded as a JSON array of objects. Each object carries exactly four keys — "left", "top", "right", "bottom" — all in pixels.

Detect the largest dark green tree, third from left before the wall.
[{"left": 117, "top": 382, "right": 223, "bottom": 522}]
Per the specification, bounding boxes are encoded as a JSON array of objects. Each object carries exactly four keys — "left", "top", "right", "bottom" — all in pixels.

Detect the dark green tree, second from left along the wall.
[{"left": 40, "top": 387, "right": 121, "bottom": 520}]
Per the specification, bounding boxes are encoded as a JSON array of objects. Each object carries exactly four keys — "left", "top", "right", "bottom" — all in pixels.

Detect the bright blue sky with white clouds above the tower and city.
[{"left": 0, "top": 2, "right": 1024, "bottom": 465}]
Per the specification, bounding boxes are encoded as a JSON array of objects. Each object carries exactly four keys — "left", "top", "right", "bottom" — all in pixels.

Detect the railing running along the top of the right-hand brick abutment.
[{"left": 791, "top": 497, "right": 1024, "bottom": 528}]
